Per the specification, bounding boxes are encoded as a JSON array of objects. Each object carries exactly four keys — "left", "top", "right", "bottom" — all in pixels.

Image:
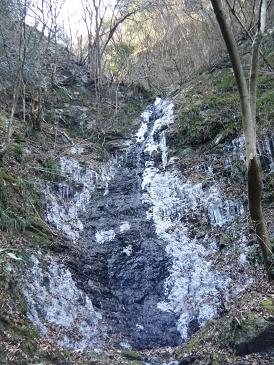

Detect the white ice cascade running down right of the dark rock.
[{"left": 137, "top": 100, "right": 250, "bottom": 339}]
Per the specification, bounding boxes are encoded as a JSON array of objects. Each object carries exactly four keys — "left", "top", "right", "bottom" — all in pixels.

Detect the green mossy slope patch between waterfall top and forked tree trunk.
[{"left": 176, "top": 69, "right": 241, "bottom": 146}]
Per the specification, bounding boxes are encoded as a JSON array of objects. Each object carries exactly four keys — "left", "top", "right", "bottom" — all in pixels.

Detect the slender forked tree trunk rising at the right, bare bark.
[{"left": 211, "top": 0, "right": 272, "bottom": 280}]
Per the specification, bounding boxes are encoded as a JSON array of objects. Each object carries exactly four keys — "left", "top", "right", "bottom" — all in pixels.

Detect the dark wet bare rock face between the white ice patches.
[{"left": 74, "top": 99, "right": 182, "bottom": 349}]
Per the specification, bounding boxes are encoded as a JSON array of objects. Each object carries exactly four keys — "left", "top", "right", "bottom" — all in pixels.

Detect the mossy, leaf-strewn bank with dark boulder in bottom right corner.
[{"left": 177, "top": 308, "right": 274, "bottom": 365}]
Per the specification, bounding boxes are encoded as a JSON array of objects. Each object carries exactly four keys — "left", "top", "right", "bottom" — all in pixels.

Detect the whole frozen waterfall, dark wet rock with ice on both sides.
[{"left": 26, "top": 98, "right": 255, "bottom": 349}]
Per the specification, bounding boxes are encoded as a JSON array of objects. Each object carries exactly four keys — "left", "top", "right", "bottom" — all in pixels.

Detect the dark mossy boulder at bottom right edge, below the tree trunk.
[{"left": 233, "top": 313, "right": 274, "bottom": 355}]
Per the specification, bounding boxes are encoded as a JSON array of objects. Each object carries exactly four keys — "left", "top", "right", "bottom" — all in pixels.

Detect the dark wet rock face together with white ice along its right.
[{"left": 69, "top": 99, "right": 250, "bottom": 349}]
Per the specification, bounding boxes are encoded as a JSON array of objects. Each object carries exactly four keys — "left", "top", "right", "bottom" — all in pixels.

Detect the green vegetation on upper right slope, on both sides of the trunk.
[{"left": 176, "top": 64, "right": 274, "bottom": 147}]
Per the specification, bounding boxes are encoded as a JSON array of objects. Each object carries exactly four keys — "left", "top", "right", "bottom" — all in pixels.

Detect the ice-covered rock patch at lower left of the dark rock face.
[{"left": 24, "top": 253, "right": 104, "bottom": 349}]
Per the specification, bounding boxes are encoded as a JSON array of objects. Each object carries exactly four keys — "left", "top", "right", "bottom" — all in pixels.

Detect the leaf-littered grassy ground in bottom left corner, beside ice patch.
[{"left": 0, "top": 255, "right": 87, "bottom": 365}]
